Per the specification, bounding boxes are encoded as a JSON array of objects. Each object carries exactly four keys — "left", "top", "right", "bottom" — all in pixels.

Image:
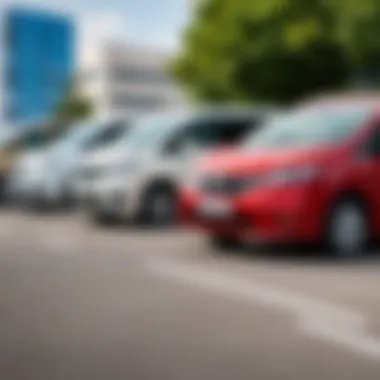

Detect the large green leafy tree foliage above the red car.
[{"left": 171, "top": 0, "right": 380, "bottom": 103}]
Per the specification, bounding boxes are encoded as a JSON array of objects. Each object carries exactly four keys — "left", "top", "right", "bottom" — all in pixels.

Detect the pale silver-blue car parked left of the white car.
[{"left": 9, "top": 120, "right": 129, "bottom": 206}]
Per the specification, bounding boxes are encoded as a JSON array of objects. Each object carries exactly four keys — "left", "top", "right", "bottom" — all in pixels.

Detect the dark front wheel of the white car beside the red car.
[{"left": 139, "top": 186, "right": 177, "bottom": 226}]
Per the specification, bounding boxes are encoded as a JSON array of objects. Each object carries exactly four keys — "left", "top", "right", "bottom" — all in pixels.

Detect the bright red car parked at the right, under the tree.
[{"left": 179, "top": 98, "right": 380, "bottom": 257}]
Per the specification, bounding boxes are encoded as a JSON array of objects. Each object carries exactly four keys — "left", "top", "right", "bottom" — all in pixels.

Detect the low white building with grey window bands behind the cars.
[{"left": 81, "top": 42, "right": 185, "bottom": 117}]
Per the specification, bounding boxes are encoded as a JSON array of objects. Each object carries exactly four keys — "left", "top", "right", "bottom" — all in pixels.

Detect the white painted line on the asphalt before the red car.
[{"left": 147, "top": 261, "right": 380, "bottom": 362}]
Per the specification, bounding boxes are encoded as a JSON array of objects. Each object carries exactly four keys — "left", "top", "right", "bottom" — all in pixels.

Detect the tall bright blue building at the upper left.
[{"left": 0, "top": 8, "right": 75, "bottom": 128}]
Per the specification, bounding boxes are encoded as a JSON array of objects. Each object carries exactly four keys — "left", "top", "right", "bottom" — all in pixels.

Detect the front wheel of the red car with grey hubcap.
[{"left": 326, "top": 199, "right": 370, "bottom": 259}]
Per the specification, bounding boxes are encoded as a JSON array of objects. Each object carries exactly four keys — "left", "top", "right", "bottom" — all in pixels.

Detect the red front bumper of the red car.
[{"left": 179, "top": 184, "right": 323, "bottom": 242}]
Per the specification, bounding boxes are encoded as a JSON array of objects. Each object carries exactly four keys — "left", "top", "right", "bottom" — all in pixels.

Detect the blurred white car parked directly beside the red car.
[{"left": 81, "top": 107, "right": 269, "bottom": 225}]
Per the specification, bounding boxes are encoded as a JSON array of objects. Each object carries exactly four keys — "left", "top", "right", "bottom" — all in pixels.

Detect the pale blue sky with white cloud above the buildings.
[{"left": 0, "top": 0, "right": 191, "bottom": 51}]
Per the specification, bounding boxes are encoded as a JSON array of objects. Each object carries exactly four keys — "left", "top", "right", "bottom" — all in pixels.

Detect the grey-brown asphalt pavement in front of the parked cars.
[{"left": 0, "top": 210, "right": 380, "bottom": 380}]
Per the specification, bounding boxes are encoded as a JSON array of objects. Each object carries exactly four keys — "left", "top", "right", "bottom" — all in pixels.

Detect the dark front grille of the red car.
[{"left": 200, "top": 177, "right": 251, "bottom": 195}]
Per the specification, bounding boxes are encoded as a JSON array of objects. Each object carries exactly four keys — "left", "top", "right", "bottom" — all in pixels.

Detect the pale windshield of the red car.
[{"left": 245, "top": 106, "right": 369, "bottom": 150}]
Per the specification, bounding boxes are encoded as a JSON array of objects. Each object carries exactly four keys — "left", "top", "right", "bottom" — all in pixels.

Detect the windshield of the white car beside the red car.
[{"left": 127, "top": 114, "right": 186, "bottom": 150}]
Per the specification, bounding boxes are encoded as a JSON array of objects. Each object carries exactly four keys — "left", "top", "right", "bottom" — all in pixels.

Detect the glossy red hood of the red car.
[{"left": 197, "top": 147, "right": 338, "bottom": 174}]
